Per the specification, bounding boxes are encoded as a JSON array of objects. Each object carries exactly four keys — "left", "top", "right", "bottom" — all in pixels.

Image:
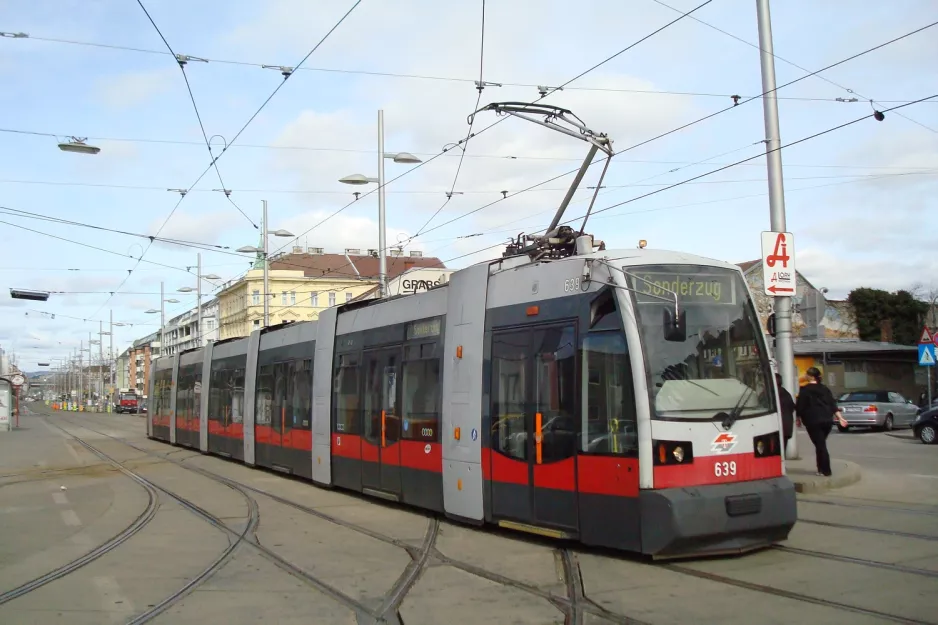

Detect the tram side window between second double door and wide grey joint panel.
[{"left": 401, "top": 343, "right": 440, "bottom": 443}]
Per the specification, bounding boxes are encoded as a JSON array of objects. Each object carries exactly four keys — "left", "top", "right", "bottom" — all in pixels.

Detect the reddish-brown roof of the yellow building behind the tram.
[{"left": 270, "top": 254, "right": 445, "bottom": 280}]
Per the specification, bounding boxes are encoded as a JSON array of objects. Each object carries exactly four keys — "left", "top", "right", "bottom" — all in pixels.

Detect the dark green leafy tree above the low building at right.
[{"left": 847, "top": 287, "right": 929, "bottom": 345}]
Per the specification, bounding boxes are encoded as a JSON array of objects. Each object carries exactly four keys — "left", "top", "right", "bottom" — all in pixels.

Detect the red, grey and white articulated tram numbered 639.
[{"left": 147, "top": 102, "right": 796, "bottom": 558}]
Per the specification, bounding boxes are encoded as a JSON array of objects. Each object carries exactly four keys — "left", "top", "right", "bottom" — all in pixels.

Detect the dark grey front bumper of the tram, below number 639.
[{"left": 639, "top": 477, "right": 798, "bottom": 559}]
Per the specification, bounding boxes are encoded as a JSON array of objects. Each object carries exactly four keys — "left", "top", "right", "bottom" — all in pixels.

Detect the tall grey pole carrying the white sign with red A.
[{"left": 756, "top": 0, "right": 798, "bottom": 460}]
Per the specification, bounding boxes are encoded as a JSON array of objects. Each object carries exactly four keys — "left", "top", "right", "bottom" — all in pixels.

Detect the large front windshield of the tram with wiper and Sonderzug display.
[{"left": 623, "top": 265, "right": 775, "bottom": 420}]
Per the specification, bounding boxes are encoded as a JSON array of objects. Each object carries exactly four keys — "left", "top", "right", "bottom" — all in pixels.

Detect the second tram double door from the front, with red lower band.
[{"left": 362, "top": 347, "right": 401, "bottom": 496}]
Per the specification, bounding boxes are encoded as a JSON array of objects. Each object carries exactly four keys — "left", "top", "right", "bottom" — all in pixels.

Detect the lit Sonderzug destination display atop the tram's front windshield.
[{"left": 626, "top": 269, "right": 736, "bottom": 304}]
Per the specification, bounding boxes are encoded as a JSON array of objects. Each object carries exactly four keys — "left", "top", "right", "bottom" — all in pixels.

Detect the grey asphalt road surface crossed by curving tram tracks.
[{"left": 0, "top": 404, "right": 938, "bottom": 625}]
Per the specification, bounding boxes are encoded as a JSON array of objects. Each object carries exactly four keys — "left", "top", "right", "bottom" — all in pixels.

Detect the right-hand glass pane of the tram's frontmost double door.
[{"left": 534, "top": 326, "right": 577, "bottom": 463}]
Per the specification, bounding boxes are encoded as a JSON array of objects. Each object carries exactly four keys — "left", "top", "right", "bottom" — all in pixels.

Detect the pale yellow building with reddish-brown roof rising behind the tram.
[{"left": 218, "top": 248, "right": 443, "bottom": 340}]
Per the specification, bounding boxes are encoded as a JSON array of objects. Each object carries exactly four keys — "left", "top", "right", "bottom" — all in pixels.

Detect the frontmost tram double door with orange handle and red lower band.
[{"left": 490, "top": 324, "right": 577, "bottom": 529}]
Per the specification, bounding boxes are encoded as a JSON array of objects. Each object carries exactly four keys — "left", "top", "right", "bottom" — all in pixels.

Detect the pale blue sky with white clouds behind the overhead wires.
[{"left": 0, "top": 0, "right": 938, "bottom": 370}]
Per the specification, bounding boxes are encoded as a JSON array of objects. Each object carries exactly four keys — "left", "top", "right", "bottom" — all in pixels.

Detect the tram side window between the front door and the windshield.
[{"left": 579, "top": 332, "right": 638, "bottom": 456}]
